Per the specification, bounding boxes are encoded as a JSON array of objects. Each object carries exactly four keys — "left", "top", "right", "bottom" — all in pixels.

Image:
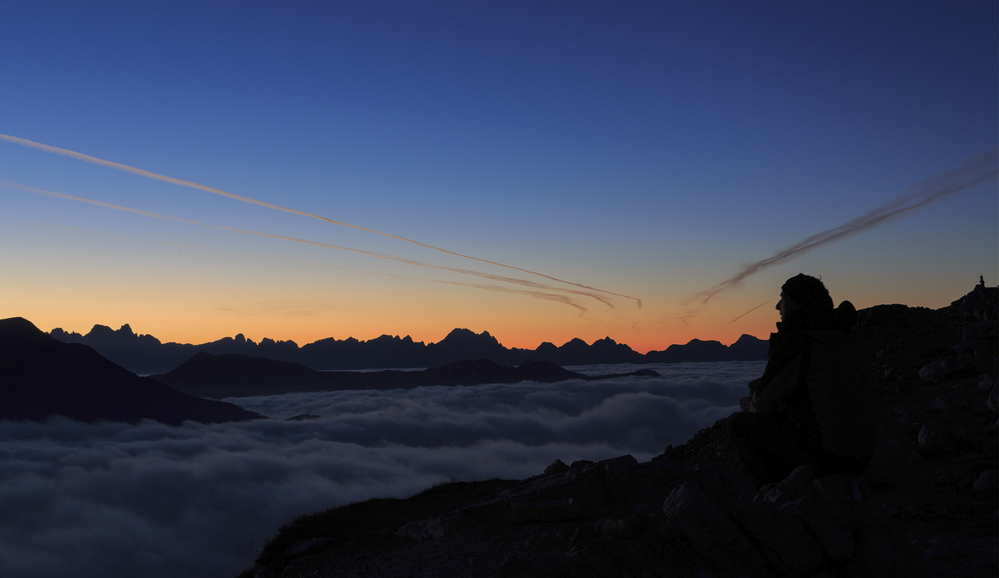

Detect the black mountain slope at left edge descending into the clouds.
[{"left": 0, "top": 317, "right": 263, "bottom": 425}]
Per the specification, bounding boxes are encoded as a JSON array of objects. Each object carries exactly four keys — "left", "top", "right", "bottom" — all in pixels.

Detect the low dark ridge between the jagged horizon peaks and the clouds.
[{"left": 155, "top": 353, "right": 659, "bottom": 398}]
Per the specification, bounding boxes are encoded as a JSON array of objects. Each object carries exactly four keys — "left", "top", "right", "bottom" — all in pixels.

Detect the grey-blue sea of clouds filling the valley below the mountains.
[{"left": 0, "top": 362, "right": 764, "bottom": 578}]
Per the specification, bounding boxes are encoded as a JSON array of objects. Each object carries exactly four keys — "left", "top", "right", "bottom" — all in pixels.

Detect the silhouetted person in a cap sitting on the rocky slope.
[{"left": 729, "top": 274, "right": 878, "bottom": 484}]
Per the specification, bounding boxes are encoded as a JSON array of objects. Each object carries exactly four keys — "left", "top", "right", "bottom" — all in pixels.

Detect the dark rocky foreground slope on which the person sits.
[{"left": 241, "top": 287, "right": 999, "bottom": 578}]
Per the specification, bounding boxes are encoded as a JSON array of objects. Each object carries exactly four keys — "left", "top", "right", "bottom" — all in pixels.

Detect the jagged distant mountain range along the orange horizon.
[{"left": 50, "top": 324, "right": 769, "bottom": 374}]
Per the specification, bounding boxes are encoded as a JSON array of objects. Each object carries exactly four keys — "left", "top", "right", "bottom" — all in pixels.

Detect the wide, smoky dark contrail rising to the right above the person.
[{"left": 684, "top": 149, "right": 999, "bottom": 305}]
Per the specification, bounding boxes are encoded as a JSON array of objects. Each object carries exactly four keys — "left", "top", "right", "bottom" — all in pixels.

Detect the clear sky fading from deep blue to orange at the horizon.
[{"left": 0, "top": 0, "right": 999, "bottom": 352}]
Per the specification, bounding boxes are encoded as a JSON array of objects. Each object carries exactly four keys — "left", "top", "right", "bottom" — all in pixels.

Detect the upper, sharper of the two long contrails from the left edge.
[{"left": 0, "top": 134, "right": 642, "bottom": 308}]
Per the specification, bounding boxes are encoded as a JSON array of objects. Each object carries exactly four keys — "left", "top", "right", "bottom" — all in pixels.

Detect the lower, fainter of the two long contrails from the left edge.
[{"left": 0, "top": 181, "right": 614, "bottom": 313}]
